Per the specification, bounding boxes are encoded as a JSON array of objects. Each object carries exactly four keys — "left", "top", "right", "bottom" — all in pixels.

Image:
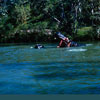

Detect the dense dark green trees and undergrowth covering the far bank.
[{"left": 0, "top": 0, "right": 100, "bottom": 43}]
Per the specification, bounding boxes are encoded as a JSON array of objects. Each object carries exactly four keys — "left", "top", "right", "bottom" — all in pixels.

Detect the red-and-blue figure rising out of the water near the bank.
[{"left": 57, "top": 32, "right": 77, "bottom": 48}]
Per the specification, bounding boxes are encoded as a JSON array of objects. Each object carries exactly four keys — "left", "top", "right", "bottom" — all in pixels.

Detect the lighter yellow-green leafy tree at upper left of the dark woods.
[{"left": 14, "top": 0, "right": 31, "bottom": 28}]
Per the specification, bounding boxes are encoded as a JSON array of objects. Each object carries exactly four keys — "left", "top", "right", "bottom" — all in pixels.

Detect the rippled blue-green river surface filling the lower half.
[{"left": 0, "top": 43, "right": 100, "bottom": 94}]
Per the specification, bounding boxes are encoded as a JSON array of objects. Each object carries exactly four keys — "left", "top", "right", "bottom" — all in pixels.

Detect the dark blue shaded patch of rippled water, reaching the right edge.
[{"left": 24, "top": 62, "right": 100, "bottom": 80}]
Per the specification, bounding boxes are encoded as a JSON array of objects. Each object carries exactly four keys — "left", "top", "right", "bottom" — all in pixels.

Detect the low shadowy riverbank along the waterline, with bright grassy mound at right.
[{"left": 0, "top": 26, "right": 100, "bottom": 43}]
